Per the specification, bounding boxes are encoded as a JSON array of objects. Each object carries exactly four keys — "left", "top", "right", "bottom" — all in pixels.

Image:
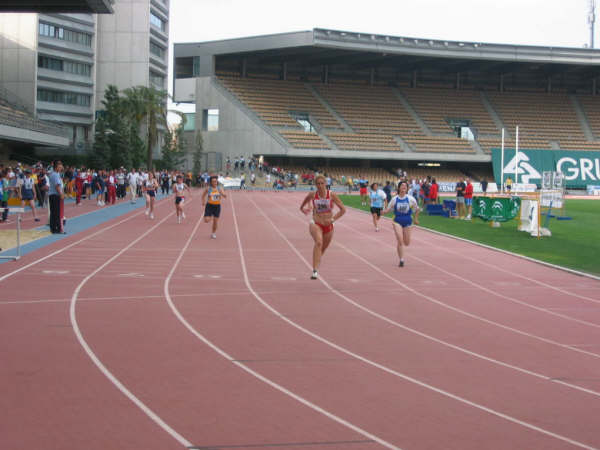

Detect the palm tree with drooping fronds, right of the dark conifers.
[{"left": 123, "top": 86, "right": 169, "bottom": 170}]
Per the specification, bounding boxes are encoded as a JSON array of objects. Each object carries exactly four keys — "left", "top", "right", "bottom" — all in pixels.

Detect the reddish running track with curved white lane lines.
[{"left": 0, "top": 192, "right": 600, "bottom": 450}]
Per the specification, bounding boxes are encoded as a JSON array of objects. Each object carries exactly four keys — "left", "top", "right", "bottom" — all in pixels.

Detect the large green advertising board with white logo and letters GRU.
[{"left": 492, "top": 148, "right": 600, "bottom": 188}]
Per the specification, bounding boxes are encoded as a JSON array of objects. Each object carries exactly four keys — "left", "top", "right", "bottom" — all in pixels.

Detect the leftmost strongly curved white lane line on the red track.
[{"left": 69, "top": 213, "right": 192, "bottom": 447}]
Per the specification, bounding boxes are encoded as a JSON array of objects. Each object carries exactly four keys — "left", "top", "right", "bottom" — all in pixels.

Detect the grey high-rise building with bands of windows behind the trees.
[{"left": 0, "top": 0, "right": 169, "bottom": 151}]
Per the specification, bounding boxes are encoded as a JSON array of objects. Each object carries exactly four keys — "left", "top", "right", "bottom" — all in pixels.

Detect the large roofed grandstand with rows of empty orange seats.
[{"left": 174, "top": 29, "right": 600, "bottom": 186}]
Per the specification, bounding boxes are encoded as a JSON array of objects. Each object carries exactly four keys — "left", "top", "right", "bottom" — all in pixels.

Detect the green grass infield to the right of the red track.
[{"left": 340, "top": 195, "right": 600, "bottom": 275}]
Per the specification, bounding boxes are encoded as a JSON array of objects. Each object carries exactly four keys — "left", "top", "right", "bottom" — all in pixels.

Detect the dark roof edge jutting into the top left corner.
[{"left": 0, "top": 0, "right": 114, "bottom": 14}]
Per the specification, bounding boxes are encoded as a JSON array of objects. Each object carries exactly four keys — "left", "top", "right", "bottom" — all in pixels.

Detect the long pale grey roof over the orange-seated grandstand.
[{"left": 173, "top": 28, "right": 600, "bottom": 78}]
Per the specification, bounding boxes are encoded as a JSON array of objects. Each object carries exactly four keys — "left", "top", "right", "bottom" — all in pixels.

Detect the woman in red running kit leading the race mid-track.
[{"left": 300, "top": 175, "right": 346, "bottom": 280}]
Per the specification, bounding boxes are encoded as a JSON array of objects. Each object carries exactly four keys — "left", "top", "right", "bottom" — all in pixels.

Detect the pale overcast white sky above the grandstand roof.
[{"left": 169, "top": 0, "right": 600, "bottom": 116}]
